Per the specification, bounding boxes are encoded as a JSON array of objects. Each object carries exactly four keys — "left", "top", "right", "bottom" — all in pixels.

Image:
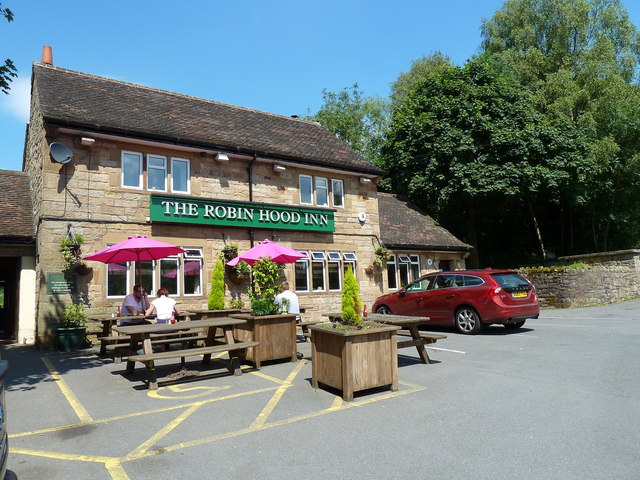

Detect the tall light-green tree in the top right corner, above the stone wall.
[{"left": 482, "top": 0, "right": 640, "bottom": 252}]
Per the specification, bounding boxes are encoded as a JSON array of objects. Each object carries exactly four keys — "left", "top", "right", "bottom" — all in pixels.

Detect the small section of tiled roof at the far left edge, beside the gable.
[{"left": 0, "top": 170, "right": 35, "bottom": 243}]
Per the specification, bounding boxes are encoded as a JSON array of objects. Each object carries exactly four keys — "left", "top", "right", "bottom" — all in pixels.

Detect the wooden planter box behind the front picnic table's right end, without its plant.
[{"left": 230, "top": 313, "right": 298, "bottom": 368}]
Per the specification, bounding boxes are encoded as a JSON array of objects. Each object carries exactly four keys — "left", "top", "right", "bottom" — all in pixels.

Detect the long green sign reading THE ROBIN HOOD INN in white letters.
[{"left": 149, "top": 195, "right": 335, "bottom": 232}]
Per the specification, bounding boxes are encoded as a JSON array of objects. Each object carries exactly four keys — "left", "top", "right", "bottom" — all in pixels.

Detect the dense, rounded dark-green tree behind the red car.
[{"left": 380, "top": 58, "right": 589, "bottom": 263}]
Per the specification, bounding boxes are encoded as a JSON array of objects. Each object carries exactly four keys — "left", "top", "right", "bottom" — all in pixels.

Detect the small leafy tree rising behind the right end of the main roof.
[{"left": 305, "top": 83, "right": 389, "bottom": 162}]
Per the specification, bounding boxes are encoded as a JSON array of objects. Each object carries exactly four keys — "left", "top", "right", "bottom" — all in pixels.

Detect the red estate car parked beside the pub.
[{"left": 373, "top": 268, "right": 540, "bottom": 334}]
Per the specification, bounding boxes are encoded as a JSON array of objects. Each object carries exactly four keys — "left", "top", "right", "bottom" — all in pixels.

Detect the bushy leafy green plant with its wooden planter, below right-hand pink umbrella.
[{"left": 231, "top": 258, "right": 298, "bottom": 368}]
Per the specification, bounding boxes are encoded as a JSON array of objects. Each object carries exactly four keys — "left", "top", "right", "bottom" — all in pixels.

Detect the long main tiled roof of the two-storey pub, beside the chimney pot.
[{"left": 33, "top": 63, "right": 384, "bottom": 175}]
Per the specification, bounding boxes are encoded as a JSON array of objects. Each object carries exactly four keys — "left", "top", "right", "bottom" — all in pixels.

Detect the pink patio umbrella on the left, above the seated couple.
[{"left": 84, "top": 235, "right": 185, "bottom": 283}]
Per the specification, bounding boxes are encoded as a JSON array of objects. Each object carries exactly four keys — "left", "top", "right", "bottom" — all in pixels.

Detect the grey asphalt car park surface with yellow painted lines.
[{"left": 2, "top": 300, "right": 640, "bottom": 480}]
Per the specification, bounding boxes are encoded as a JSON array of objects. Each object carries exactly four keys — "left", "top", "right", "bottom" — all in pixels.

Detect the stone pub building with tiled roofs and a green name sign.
[{"left": 0, "top": 49, "right": 471, "bottom": 347}]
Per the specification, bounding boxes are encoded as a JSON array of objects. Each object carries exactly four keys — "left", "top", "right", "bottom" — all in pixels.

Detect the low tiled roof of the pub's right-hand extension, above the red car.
[{"left": 378, "top": 193, "right": 473, "bottom": 251}]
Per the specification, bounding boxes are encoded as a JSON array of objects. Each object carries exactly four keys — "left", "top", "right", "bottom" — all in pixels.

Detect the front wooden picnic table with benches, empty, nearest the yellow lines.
[{"left": 113, "top": 317, "right": 258, "bottom": 390}]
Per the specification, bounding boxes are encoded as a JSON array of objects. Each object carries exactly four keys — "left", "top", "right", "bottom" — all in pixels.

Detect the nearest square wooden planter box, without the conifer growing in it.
[{"left": 309, "top": 325, "right": 400, "bottom": 401}]
